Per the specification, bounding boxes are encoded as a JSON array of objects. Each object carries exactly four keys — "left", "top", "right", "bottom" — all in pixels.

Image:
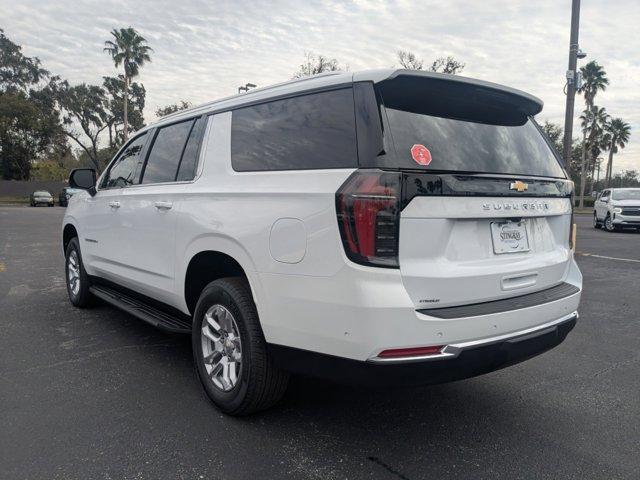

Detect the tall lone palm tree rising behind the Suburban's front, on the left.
[{"left": 104, "top": 27, "right": 153, "bottom": 142}]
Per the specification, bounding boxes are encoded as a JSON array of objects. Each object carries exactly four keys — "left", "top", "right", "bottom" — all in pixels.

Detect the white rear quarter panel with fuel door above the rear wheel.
[{"left": 176, "top": 112, "right": 354, "bottom": 316}]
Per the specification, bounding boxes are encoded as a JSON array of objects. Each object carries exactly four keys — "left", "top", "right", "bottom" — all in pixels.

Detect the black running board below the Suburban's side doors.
[{"left": 89, "top": 285, "right": 191, "bottom": 333}]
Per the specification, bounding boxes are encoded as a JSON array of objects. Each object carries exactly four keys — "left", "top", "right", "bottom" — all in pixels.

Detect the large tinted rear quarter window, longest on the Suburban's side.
[{"left": 231, "top": 88, "right": 358, "bottom": 172}]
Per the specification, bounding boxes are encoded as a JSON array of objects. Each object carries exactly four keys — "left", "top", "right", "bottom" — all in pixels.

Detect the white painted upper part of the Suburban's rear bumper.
[{"left": 256, "top": 259, "right": 582, "bottom": 362}]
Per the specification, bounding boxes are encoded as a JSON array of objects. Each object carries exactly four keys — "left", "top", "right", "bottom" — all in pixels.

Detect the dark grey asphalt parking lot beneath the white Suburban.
[{"left": 0, "top": 207, "right": 640, "bottom": 479}]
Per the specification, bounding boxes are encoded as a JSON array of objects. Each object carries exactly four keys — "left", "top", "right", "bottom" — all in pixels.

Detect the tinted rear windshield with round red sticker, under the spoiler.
[{"left": 381, "top": 80, "right": 565, "bottom": 178}]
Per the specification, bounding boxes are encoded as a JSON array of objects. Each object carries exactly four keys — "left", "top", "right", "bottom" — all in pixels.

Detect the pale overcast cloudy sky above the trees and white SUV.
[{"left": 0, "top": 0, "right": 640, "bottom": 170}]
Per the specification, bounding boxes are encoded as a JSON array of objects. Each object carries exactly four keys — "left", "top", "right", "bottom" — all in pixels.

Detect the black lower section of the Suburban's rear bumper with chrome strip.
[{"left": 269, "top": 312, "right": 578, "bottom": 386}]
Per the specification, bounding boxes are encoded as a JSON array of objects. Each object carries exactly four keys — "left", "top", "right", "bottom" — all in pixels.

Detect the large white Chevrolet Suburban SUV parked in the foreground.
[{"left": 62, "top": 70, "right": 582, "bottom": 415}]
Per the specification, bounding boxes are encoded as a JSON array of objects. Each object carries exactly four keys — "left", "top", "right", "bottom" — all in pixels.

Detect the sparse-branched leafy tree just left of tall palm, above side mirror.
[{"left": 56, "top": 80, "right": 109, "bottom": 171}]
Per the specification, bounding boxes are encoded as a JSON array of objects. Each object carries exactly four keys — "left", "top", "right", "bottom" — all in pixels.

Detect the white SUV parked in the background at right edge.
[{"left": 593, "top": 188, "right": 640, "bottom": 232}]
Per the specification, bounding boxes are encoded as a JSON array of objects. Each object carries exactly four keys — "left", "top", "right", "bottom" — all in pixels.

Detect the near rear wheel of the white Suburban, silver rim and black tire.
[{"left": 191, "top": 277, "right": 289, "bottom": 416}]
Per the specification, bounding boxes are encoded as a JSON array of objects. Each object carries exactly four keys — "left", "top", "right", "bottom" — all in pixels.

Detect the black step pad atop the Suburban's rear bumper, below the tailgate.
[{"left": 418, "top": 283, "right": 580, "bottom": 318}]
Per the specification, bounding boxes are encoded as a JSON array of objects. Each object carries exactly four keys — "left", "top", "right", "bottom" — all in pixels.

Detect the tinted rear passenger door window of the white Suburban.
[{"left": 142, "top": 120, "right": 193, "bottom": 183}]
